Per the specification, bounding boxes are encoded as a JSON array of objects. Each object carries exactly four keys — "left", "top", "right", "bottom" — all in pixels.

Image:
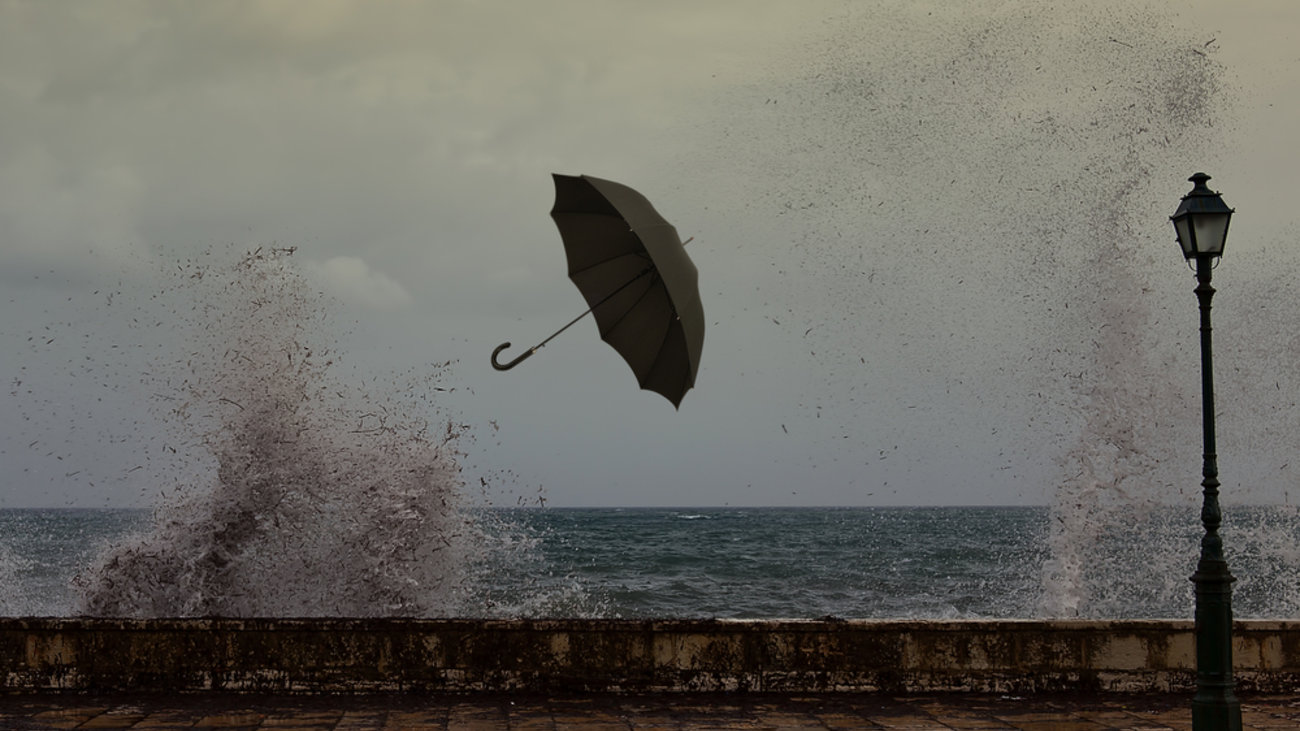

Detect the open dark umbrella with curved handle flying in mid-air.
[{"left": 491, "top": 174, "right": 705, "bottom": 407}]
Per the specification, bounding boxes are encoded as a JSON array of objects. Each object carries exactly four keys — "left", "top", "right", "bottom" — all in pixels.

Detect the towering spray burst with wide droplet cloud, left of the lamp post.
[{"left": 686, "top": 0, "right": 1229, "bottom": 617}]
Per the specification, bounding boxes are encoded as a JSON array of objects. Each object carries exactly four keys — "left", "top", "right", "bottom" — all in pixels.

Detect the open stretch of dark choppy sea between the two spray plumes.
[{"left": 486, "top": 507, "right": 1047, "bottom": 618}]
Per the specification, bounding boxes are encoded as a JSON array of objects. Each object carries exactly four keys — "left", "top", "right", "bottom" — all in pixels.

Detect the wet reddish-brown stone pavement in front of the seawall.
[{"left": 0, "top": 692, "right": 1300, "bottom": 731}]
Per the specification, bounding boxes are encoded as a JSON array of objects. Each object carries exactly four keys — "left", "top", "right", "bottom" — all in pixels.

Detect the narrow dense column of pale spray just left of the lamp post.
[{"left": 1037, "top": 217, "right": 1191, "bottom": 617}]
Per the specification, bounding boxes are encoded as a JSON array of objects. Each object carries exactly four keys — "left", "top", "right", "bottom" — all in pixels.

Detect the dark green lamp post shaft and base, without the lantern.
[{"left": 1192, "top": 256, "right": 1242, "bottom": 731}]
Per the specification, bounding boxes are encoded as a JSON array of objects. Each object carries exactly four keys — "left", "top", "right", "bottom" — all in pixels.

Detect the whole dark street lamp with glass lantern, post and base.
[{"left": 1170, "top": 173, "right": 1242, "bottom": 731}]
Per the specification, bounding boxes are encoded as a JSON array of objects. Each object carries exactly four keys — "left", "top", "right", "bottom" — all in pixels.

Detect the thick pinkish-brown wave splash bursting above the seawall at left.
[{"left": 63, "top": 248, "right": 528, "bottom": 617}]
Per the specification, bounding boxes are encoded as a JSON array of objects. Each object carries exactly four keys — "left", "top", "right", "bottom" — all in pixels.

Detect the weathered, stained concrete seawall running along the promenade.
[{"left": 0, "top": 618, "right": 1300, "bottom": 693}]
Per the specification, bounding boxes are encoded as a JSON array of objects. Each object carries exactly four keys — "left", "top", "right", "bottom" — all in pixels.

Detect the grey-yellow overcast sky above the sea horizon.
[{"left": 0, "top": 0, "right": 1300, "bottom": 507}]
